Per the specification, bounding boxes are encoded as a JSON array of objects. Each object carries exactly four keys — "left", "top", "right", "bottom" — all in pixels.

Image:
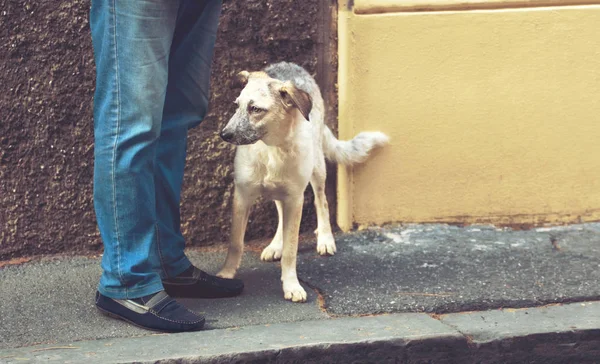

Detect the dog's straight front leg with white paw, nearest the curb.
[{"left": 281, "top": 194, "right": 306, "bottom": 302}]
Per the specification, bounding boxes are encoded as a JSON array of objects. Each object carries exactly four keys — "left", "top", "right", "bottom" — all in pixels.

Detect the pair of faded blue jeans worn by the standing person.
[{"left": 90, "top": 0, "right": 221, "bottom": 299}]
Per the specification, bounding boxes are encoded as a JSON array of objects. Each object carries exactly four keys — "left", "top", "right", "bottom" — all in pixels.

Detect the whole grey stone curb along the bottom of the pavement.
[{"left": 0, "top": 301, "right": 600, "bottom": 364}]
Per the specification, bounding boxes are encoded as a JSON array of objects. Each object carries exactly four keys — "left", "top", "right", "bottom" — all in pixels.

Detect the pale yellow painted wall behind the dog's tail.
[{"left": 338, "top": 0, "right": 600, "bottom": 230}]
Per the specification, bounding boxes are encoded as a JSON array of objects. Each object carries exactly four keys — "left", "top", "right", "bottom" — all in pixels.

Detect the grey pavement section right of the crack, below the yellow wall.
[{"left": 298, "top": 223, "right": 600, "bottom": 316}]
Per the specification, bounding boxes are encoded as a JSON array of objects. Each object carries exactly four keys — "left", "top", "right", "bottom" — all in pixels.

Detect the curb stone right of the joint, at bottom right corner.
[{"left": 440, "top": 302, "right": 600, "bottom": 363}]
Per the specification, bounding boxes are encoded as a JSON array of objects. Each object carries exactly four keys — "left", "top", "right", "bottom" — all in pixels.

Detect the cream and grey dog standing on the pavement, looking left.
[{"left": 217, "top": 62, "right": 388, "bottom": 302}]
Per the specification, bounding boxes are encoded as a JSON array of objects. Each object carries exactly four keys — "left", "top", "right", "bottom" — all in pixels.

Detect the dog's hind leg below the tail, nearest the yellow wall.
[{"left": 310, "top": 159, "right": 337, "bottom": 255}]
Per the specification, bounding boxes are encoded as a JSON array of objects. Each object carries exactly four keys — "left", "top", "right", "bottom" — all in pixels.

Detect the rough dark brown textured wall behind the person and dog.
[{"left": 0, "top": 0, "right": 336, "bottom": 260}]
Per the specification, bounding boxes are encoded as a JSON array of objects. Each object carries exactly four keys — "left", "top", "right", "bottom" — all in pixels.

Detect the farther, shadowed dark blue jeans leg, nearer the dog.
[{"left": 154, "top": 0, "right": 221, "bottom": 278}]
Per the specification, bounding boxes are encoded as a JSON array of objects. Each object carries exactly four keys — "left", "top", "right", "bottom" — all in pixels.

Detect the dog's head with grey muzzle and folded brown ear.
[{"left": 221, "top": 71, "right": 312, "bottom": 145}]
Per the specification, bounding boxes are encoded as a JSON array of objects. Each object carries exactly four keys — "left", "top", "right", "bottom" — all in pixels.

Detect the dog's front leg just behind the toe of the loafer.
[{"left": 217, "top": 186, "right": 255, "bottom": 278}]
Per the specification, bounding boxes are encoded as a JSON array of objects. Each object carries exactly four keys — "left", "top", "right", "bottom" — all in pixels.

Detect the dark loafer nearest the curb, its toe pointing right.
[{"left": 96, "top": 291, "right": 205, "bottom": 332}]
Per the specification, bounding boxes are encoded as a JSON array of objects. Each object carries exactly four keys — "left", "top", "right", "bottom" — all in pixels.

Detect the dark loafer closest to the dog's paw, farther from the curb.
[{"left": 162, "top": 266, "right": 244, "bottom": 298}]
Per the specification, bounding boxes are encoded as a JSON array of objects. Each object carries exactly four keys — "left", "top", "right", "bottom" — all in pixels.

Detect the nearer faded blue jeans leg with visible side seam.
[{"left": 90, "top": 0, "right": 180, "bottom": 299}]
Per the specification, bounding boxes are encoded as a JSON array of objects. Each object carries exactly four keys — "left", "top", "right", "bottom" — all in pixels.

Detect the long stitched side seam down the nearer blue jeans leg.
[{"left": 111, "top": 0, "right": 124, "bottom": 295}]
